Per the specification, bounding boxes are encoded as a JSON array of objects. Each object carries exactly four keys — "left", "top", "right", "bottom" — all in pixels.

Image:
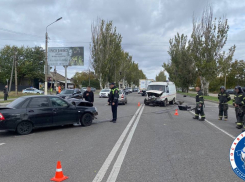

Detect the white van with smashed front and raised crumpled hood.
[{"left": 144, "top": 82, "right": 176, "bottom": 106}]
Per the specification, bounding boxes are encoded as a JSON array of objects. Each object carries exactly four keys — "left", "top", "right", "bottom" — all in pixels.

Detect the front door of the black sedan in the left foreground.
[{"left": 50, "top": 97, "right": 78, "bottom": 125}]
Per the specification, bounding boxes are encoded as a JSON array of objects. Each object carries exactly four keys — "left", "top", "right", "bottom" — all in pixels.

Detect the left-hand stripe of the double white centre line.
[{"left": 93, "top": 105, "right": 142, "bottom": 182}]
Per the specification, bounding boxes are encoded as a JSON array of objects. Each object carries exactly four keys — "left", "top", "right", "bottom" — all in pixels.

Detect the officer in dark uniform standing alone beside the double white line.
[{"left": 108, "top": 83, "right": 119, "bottom": 123}]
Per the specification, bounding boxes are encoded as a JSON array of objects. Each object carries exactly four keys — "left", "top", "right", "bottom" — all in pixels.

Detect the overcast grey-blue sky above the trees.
[{"left": 0, "top": 0, "right": 245, "bottom": 79}]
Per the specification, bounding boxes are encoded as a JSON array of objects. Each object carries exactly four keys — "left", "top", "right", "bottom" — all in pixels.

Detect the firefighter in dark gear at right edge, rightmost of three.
[{"left": 233, "top": 86, "right": 245, "bottom": 129}]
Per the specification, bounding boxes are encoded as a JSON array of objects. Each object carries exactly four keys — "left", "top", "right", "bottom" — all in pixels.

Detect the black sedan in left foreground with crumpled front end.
[{"left": 0, "top": 95, "right": 98, "bottom": 135}]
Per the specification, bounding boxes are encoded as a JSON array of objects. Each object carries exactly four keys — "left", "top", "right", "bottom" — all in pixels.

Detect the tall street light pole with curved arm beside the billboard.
[{"left": 44, "top": 17, "right": 62, "bottom": 95}]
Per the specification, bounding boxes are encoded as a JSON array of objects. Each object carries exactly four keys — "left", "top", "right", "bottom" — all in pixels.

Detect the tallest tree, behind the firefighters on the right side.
[{"left": 190, "top": 6, "right": 235, "bottom": 95}]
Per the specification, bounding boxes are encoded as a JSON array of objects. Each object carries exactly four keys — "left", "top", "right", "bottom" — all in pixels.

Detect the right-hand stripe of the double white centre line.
[{"left": 107, "top": 106, "right": 145, "bottom": 182}]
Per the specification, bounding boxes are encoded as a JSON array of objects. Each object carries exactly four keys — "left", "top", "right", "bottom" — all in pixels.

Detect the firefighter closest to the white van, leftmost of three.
[{"left": 193, "top": 87, "right": 205, "bottom": 121}]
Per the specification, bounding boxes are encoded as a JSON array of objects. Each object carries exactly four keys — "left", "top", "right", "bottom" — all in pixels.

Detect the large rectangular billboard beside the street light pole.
[{"left": 48, "top": 47, "right": 84, "bottom": 66}]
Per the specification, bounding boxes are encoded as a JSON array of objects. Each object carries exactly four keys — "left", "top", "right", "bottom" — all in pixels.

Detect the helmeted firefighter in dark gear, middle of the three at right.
[{"left": 218, "top": 86, "right": 231, "bottom": 121}]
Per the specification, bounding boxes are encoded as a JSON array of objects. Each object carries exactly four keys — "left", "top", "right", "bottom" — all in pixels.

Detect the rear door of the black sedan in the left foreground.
[{"left": 26, "top": 97, "right": 53, "bottom": 127}]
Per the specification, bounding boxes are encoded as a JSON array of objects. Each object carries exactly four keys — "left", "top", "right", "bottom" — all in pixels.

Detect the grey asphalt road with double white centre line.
[{"left": 0, "top": 93, "right": 242, "bottom": 182}]
